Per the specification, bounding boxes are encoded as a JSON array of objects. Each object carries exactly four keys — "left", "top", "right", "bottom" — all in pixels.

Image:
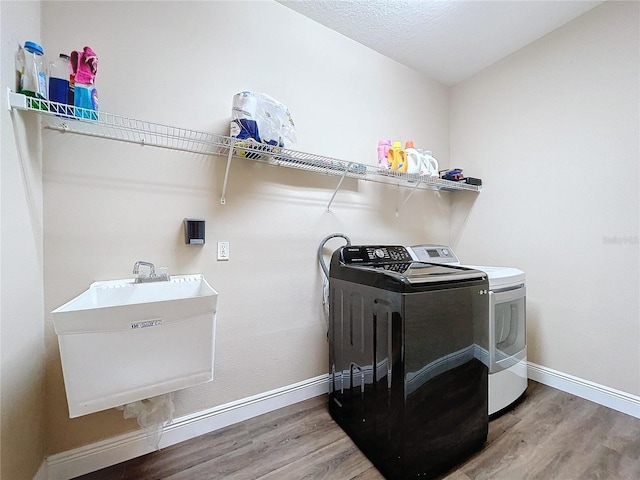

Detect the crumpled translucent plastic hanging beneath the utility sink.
[{"left": 118, "top": 392, "right": 175, "bottom": 450}]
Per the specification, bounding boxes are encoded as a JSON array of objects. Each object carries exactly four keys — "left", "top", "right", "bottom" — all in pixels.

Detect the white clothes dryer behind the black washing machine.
[{"left": 411, "top": 244, "right": 527, "bottom": 417}]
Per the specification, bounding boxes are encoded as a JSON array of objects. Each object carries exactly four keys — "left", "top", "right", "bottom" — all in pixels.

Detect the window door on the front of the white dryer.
[{"left": 489, "top": 286, "right": 527, "bottom": 373}]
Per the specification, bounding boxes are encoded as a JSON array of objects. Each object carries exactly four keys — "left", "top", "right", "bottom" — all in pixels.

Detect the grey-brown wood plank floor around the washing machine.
[{"left": 78, "top": 381, "right": 640, "bottom": 480}]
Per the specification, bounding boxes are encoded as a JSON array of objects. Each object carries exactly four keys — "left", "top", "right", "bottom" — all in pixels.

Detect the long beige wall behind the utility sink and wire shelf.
[{"left": 42, "top": 2, "right": 450, "bottom": 453}]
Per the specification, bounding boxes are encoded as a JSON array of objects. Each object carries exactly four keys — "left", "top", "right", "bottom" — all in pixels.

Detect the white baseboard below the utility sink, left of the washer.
[{"left": 43, "top": 374, "right": 329, "bottom": 480}]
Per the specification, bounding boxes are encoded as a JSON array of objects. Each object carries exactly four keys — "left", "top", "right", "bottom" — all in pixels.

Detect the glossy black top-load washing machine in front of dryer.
[{"left": 329, "top": 246, "right": 489, "bottom": 479}]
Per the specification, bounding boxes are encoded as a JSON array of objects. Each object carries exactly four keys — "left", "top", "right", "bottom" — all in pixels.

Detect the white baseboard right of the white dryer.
[{"left": 527, "top": 362, "right": 640, "bottom": 418}]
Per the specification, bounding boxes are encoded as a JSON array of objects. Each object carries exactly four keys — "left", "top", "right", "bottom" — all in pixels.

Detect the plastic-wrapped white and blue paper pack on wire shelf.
[{"left": 231, "top": 92, "right": 296, "bottom": 147}]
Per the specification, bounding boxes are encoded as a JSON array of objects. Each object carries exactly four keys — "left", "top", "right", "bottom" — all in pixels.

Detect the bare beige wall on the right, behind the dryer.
[{"left": 450, "top": 2, "right": 640, "bottom": 395}]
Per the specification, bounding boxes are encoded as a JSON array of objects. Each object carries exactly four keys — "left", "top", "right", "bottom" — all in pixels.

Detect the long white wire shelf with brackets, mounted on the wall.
[{"left": 8, "top": 89, "right": 482, "bottom": 208}]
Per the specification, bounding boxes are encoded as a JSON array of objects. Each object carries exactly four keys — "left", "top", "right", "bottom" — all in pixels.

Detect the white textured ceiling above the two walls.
[{"left": 278, "top": 0, "right": 604, "bottom": 85}]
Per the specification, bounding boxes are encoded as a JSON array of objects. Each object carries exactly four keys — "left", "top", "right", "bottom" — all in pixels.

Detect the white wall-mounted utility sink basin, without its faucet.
[{"left": 51, "top": 274, "right": 218, "bottom": 418}]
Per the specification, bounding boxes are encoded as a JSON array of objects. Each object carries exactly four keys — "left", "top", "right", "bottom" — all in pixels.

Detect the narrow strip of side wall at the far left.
[{"left": 0, "top": 1, "right": 45, "bottom": 480}]
